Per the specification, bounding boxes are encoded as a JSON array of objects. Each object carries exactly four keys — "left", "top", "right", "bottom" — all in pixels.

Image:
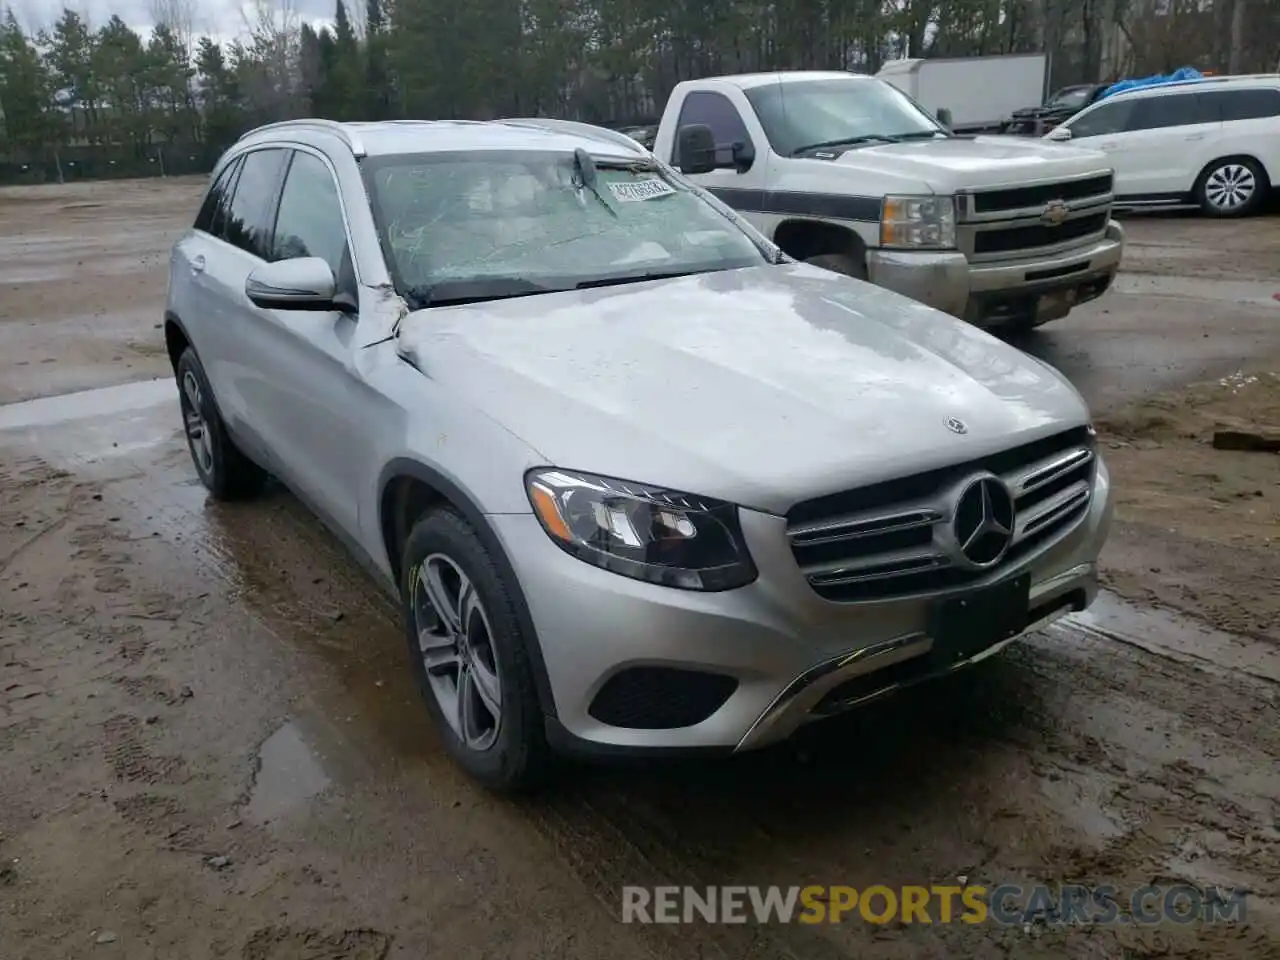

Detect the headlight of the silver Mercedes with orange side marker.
[{"left": 526, "top": 468, "right": 756, "bottom": 591}]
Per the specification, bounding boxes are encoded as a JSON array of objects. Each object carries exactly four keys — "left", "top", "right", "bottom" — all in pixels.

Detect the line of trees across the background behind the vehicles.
[{"left": 0, "top": 0, "right": 1280, "bottom": 182}]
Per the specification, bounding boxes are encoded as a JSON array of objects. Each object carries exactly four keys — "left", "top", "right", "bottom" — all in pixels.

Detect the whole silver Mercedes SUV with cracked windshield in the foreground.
[{"left": 165, "top": 120, "right": 1111, "bottom": 788}]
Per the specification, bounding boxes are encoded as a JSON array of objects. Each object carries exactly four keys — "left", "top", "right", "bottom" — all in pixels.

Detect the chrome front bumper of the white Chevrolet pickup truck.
[{"left": 867, "top": 220, "right": 1124, "bottom": 326}]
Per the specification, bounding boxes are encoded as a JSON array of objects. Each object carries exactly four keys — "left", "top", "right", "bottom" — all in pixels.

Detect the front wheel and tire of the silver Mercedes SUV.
[{"left": 401, "top": 508, "right": 550, "bottom": 792}]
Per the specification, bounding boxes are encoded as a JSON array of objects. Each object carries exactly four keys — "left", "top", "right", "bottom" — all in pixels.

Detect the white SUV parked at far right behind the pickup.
[{"left": 1044, "top": 74, "right": 1280, "bottom": 216}]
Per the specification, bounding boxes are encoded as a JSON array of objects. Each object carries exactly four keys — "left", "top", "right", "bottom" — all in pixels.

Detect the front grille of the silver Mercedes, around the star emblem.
[{"left": 787, "top": 428, "right": 1097, "bottom": 603}]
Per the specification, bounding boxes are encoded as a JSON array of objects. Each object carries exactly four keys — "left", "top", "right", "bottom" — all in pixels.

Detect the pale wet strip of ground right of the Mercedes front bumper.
[{"left": 1046, "top": 590, "right": 1280, "bottom": 684}]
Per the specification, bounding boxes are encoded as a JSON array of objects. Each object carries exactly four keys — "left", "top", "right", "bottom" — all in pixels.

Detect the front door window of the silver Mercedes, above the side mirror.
[{"left": 269, "top": 150, "right": 347, "bottom": 276}]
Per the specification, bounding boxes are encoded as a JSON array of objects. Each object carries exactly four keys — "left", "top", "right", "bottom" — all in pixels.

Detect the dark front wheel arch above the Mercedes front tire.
[{"left": 378, "top": 458, "right": 556, "bottom": 717}]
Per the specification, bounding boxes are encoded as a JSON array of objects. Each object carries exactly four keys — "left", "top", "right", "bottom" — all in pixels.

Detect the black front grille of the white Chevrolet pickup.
[{"left": 956, "top": 173, "right": 1114, "bottom": 262}]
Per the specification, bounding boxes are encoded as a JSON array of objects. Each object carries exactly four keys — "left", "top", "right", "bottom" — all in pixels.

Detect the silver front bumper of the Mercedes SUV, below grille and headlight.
[{"left": 489, "top": 461, "right": 1112, "bottom": 754}]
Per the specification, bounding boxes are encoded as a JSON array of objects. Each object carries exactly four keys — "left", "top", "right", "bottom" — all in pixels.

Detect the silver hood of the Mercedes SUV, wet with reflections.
[{"left": 399, "top": 264, "right": 1088, "bottom": 513}]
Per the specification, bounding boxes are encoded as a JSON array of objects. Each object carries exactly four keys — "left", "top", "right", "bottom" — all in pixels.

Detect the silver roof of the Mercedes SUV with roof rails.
[{"left": 239, "top": 118, "right": 648, "bottom": 157}]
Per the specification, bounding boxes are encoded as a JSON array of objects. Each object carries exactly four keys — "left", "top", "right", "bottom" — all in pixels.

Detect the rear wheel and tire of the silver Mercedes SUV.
[{"left": 174, "top": 347, "right": 266, "bottom": 500}]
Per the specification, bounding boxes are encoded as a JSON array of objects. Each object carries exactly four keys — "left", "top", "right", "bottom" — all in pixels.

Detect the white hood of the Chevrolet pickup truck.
[{"left": 827, "top": 137, "right": 1111, "bottom": 193}]
